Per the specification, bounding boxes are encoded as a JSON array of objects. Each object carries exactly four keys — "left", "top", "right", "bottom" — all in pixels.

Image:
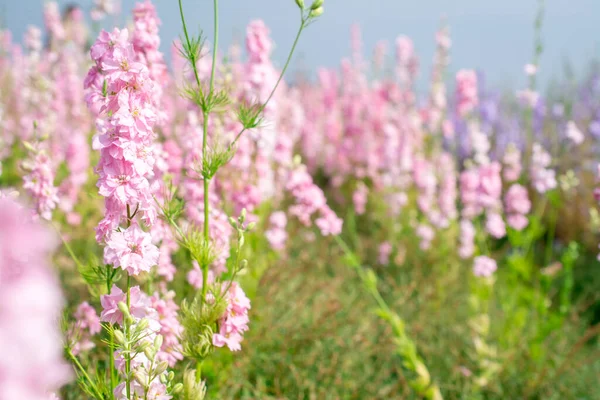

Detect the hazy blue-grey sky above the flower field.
[{"left": 0, "top": 0, "right": 600, "bottom": 89}]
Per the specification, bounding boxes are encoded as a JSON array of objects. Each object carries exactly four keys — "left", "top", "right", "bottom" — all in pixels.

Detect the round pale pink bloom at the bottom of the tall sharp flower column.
[{"left": 104, "top": 224, "right": 159, "bottom": 275}]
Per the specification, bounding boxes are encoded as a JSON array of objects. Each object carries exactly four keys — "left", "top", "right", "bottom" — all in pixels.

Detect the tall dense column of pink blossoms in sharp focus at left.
[{"left": 85, "top": 29, "right": 156, "bottom": 256}]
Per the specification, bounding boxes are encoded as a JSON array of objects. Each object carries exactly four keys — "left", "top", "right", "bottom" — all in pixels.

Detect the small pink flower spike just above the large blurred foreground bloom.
[{"left": 22, "top": 145, "right": 59, "bottom": 220}]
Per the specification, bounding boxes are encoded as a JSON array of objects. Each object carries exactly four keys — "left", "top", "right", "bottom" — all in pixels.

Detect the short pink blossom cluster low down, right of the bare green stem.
[{"left": 213, "top": 282, "right": 250, "bottom": 351}]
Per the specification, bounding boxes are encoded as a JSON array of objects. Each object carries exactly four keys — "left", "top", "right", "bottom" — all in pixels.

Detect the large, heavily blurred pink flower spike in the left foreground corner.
[{"left": 0, "top": 196, "right": 71, "bottom": 400}]
